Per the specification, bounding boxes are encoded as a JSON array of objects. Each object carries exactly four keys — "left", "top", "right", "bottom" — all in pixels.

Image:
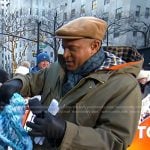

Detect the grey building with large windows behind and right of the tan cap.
[{"left": 52, "top": 0, "right": 150, "bottom": 48}]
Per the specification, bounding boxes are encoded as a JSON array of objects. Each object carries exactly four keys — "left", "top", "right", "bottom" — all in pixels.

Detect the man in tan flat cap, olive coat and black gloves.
[{"left": 0, "top": 17, "right": 143, "bottom": 150}]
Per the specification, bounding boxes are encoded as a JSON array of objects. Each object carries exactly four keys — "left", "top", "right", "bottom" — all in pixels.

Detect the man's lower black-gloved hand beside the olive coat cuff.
[{"left": 26, "top": 112, "right": 66, "bottom": 147}]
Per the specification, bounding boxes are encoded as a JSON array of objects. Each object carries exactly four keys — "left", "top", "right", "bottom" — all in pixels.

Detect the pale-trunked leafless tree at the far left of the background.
[{"left": 0, "top": 12, "right": 33, "bottom": 72}]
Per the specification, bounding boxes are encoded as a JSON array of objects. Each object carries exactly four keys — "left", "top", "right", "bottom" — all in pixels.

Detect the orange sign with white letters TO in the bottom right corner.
[{"left": 128, "top": 117, "right": 150, "bottom": 150}]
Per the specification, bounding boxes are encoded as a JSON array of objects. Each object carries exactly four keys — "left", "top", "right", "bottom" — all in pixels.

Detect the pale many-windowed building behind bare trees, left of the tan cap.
[{"left": 0, "top": 0, "right": 54, "bottom": 73}]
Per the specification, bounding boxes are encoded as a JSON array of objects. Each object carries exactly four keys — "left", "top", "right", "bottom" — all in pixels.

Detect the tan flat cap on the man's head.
[{"left": 55, "top": 17, "right": 107, "bottom": 40}]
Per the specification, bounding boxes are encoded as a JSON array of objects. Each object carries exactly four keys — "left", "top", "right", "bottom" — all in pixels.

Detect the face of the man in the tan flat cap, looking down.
[{"left": 62, "top": 38, "right": 99, "bottom": 71}]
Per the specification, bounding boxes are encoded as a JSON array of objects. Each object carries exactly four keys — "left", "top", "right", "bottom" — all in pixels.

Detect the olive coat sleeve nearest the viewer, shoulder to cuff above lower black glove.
[{"left": 60, "top": 74, "right": 141, "bottom": 150}]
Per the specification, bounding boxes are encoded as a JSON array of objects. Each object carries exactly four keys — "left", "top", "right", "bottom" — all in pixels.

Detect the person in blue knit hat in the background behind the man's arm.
[{"left": 31, "top": 52, "right": 50, "bottom": 72}]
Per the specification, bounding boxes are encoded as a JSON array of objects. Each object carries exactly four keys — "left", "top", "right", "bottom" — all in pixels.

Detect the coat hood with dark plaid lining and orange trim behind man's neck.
[{"left": 99, "top": 46, "right": 144, "bottom": 77}]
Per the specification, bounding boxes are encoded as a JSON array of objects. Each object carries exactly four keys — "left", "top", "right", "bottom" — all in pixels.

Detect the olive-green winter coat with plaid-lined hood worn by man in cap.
[{"left": 15, "top": 47, "right": 143, "bottom": 150}]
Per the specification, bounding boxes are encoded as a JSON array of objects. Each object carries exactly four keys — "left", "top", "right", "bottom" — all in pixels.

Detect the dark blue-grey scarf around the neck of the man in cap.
[{"left": 62, "top": 48, "right": 105, "bottom": 95}]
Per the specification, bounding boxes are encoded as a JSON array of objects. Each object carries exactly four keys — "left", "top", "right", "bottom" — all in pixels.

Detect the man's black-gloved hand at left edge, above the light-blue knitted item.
[{"left": 0, "top": 79, "right": 22, "bottom": 108}]
